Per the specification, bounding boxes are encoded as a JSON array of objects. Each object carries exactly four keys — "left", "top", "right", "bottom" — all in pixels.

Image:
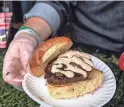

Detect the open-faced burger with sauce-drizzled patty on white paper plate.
[{"left": 30, "top": 37, "right": 103, "bottom": 99}]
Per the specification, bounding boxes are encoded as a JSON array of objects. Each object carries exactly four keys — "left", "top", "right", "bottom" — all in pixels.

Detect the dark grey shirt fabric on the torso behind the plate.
[{"left": 41, "top": 1, "right": 124, "bottom": 52}]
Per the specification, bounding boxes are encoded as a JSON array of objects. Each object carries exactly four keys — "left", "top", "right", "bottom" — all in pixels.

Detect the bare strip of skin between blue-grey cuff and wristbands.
[{"left": 24, "top": 17, "right": 52, "bottom": 41}]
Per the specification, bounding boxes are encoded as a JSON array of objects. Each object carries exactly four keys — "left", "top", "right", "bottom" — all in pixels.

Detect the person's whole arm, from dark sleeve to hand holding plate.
[{"left": 3, "top": 2, "right": 71, "bottom": 87}]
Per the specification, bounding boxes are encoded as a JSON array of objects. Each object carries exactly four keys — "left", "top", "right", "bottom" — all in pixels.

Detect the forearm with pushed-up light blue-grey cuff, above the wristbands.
[{"left": 16, "top": 2, "right": 68, "bottom": 41}]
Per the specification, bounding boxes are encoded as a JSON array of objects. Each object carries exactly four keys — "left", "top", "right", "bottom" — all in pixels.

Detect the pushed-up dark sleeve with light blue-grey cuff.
[{"left": 24, "top": 2, "right": 70, "bottom": 33}]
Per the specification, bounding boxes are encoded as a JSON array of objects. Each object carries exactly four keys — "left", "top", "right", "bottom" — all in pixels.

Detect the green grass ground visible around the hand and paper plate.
[{"left": 0, "top": 48, "right": 124, "bottom": 107}]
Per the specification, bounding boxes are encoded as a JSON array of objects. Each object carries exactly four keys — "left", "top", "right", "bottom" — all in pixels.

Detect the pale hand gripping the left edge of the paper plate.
[{"left": 3, "top": 33, "right": 37, "bottom": 87}]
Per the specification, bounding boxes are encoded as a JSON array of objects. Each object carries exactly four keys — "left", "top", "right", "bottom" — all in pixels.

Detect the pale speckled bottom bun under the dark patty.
[{"left": 47, "top": 69, "right": 103, "bottom": 99}]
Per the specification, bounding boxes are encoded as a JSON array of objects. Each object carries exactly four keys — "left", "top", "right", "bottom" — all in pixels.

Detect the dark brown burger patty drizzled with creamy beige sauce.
[{"left": 45, "top": 51, "right": 93, "bottom": 85}]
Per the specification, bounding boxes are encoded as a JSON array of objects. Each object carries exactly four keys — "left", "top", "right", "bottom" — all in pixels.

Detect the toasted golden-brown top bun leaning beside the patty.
[{"left": 30, "top": 36, "right": 73, "bottom": 77}]
